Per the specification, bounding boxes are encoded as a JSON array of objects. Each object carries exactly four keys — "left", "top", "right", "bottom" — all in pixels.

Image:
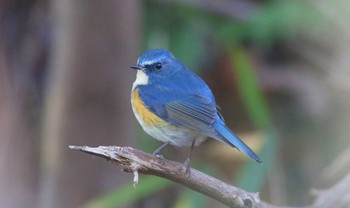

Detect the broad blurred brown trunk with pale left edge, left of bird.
[{"left": 39, "top": 0, "right": 139, "bottom": 208}]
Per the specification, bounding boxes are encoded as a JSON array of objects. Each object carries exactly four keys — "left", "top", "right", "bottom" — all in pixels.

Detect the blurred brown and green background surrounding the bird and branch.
[{"left": 0, "top": 0, "right": 350, "bottom": 208}]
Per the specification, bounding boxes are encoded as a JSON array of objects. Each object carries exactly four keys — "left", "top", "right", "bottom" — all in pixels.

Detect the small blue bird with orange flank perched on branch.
[{"left": 130, "top": 48, "right": 262, "bottom": 169}]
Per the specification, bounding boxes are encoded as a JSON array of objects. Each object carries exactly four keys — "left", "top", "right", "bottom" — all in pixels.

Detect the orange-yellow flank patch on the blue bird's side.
[{"left": 131, "top": 88, "right": 165, "bottom": 125}]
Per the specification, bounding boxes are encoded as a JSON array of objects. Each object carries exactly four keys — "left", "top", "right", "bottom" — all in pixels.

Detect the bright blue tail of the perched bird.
[{"left": 213, "top": 119, "right": 262, "bottom": 163}]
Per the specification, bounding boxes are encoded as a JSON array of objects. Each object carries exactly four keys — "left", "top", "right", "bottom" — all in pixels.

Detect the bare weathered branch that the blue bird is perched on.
[{"left": 69, "top": 146, "right": 261, "bottom": 207}]
